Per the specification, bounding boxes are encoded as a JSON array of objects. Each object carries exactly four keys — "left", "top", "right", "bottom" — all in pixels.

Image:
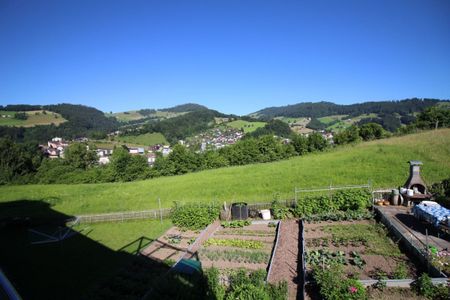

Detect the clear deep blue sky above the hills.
[{"left": 0, "top": 0, "right": 450, "bottom": 114}]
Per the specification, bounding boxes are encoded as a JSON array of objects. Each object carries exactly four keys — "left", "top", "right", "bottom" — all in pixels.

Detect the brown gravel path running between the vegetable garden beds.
[{"left": 269, "top": 220, "right": 300, "bottom": 299}]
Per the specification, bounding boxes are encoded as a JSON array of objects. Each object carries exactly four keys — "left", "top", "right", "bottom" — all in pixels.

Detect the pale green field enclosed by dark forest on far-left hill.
[{"left": 0, "top": 110, "right": 66, "bottom": 127}]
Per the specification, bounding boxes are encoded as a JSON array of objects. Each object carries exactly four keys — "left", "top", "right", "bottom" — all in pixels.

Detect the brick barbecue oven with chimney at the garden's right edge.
[{"left": 402, "top": 160, "right": 432, "bottom": 203}]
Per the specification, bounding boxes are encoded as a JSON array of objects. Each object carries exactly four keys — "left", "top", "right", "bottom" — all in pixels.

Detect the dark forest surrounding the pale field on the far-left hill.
[{"left": 0, "top": 104, "right": 119, "bottom": 143}]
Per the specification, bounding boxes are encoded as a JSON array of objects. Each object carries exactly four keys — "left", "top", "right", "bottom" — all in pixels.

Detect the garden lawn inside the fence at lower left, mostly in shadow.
[{"left": 0, "top": 216, "right": 171, "bottom": 299}]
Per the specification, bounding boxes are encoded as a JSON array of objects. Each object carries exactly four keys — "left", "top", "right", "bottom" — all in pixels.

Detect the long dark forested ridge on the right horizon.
[{"left": 252, "top": 98, "right": 449, "bottom": 119}]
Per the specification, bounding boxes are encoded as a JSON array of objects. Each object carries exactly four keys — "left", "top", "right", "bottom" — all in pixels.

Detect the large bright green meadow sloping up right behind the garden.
[{"left": 0, "top": 129, "right": 450, "bottom": 215}]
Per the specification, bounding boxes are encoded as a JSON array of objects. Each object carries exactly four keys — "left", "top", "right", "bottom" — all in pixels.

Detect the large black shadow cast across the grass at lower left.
[{"left": 0, "top": 200, "right": 205, "bottom": 300}]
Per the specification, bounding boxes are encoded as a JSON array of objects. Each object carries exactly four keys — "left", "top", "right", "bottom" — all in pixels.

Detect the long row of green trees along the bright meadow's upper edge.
[{"left": 0, "top": 133, "right": 329, "bottom": 184}]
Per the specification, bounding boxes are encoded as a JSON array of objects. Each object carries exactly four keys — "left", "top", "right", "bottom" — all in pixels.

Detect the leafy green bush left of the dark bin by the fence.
[{"left": 171, "top": 203, "right": 220, "bottom": 230}]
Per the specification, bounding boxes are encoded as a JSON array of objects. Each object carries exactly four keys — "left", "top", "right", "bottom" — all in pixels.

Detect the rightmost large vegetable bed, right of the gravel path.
[{"left": 304, "top": 220, "right": 417, "bottom": 279}]
